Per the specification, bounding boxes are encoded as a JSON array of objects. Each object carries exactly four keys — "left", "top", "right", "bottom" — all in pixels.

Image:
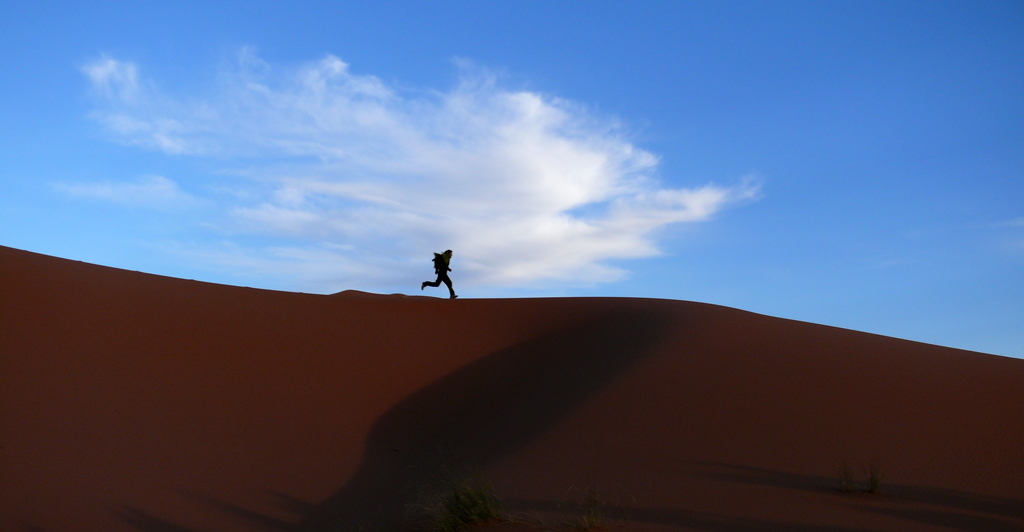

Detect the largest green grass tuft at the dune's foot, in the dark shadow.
[{"left": 427, "top": 476, "right": 505, "bottom": 532}]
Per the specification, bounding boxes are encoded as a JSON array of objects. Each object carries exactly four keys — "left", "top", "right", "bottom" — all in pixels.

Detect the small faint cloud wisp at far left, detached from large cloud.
[{"left": 53, "top": 176, "right": 201, "bottom": 209}]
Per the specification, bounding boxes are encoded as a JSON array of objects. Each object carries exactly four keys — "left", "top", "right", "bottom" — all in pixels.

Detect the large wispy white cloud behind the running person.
[{"left": 83, "top": 48, "right": 760, "bottom": 286}]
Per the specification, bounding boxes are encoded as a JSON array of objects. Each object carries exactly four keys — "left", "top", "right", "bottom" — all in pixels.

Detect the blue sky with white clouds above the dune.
[{"left": 0, "top": 1, "right": 1024, "bottom": 357}]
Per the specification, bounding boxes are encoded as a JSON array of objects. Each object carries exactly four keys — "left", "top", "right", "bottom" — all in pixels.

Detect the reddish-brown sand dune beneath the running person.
[{"left": 0, "top": 248, "right": 1024, "bottom": 532}]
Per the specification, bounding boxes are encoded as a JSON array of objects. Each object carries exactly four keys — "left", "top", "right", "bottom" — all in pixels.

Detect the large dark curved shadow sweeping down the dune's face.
[{"left": 121, "top": 309, "right": 668, "bottom": 532}]
